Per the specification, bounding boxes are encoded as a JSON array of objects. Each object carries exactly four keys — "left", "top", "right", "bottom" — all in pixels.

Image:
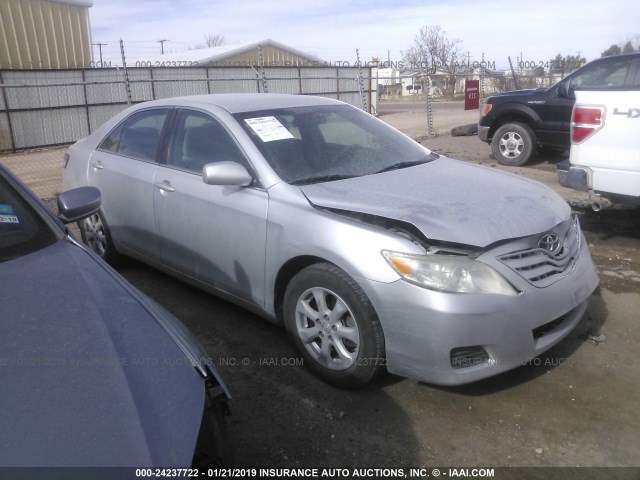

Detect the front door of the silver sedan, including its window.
[{"left": 153, "top": 109, "right": 268, "bottom": 306}]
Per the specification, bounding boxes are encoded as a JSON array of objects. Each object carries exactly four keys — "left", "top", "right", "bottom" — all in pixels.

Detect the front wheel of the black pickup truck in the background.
[{"left": 491, "top": 123, "right": 536, "bottom": 167}]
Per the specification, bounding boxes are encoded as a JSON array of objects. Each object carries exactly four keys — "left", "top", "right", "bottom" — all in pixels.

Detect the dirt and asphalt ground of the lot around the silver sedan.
[{"left": 5, "top": 107, "right": 640, "bottom": 479}]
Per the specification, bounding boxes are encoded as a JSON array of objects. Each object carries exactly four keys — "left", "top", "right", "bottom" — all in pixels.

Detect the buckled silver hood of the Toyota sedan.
[{"left": 300, "top": 157, "right": 570, "bottom": 247}]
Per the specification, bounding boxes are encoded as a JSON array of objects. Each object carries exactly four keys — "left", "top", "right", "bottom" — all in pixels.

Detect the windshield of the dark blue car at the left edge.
[{"left": 0, "top": 175, "right": 58, "bottom": 263}]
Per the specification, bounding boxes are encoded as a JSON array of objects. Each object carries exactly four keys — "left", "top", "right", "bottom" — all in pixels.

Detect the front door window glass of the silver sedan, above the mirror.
[{"left": 167, "top": 110, "right": 247, "bottom": 174}]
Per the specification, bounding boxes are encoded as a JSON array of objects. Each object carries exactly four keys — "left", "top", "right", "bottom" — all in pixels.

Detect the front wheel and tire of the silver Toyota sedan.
[{"left": 284, "top": 263, "right": 386, "bottom": 388}]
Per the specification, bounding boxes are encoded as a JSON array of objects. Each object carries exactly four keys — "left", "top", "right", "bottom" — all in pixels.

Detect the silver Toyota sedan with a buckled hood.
[{"left": 64, "top": 94, "right": 598, "bottom": 387}]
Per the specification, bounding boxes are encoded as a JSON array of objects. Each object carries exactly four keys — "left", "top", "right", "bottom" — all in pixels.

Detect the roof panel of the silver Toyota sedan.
[{"left": 139, "top": 93, "right": 344, "bottom": 113}]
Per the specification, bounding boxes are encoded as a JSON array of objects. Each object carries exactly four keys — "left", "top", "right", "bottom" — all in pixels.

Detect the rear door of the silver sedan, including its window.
[{"left": 89, "top": 108, "right": 171, "bottom": 258}]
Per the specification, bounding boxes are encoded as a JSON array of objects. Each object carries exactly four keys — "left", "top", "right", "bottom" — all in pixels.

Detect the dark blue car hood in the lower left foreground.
[{"left": 0, "top": 241, "right": 205, "bottom": 467}]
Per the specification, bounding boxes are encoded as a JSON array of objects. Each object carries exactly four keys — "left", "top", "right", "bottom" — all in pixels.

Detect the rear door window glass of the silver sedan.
[{"left": 98, "top": 109, "right": 169, "bottom": 161}]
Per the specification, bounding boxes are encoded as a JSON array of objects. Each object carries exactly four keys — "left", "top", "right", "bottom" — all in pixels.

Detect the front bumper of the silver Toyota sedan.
[{"left": 360, "top": 221, "right": 599, "bottom": 385}]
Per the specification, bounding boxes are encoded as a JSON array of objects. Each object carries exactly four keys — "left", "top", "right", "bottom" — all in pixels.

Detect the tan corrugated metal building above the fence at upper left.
[{"left": 0, "top": 0, "right": 93, "bottom": 69}]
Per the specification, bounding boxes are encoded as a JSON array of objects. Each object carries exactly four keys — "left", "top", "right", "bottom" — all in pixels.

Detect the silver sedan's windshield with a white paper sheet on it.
[{"left": 235, "top": 105, "right": 438, "bottom": 185}]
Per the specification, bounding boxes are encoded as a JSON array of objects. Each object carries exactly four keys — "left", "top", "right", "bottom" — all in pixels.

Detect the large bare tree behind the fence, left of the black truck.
[{"left": 402, "top": 25, "right": 464, "bottom": 97}]
